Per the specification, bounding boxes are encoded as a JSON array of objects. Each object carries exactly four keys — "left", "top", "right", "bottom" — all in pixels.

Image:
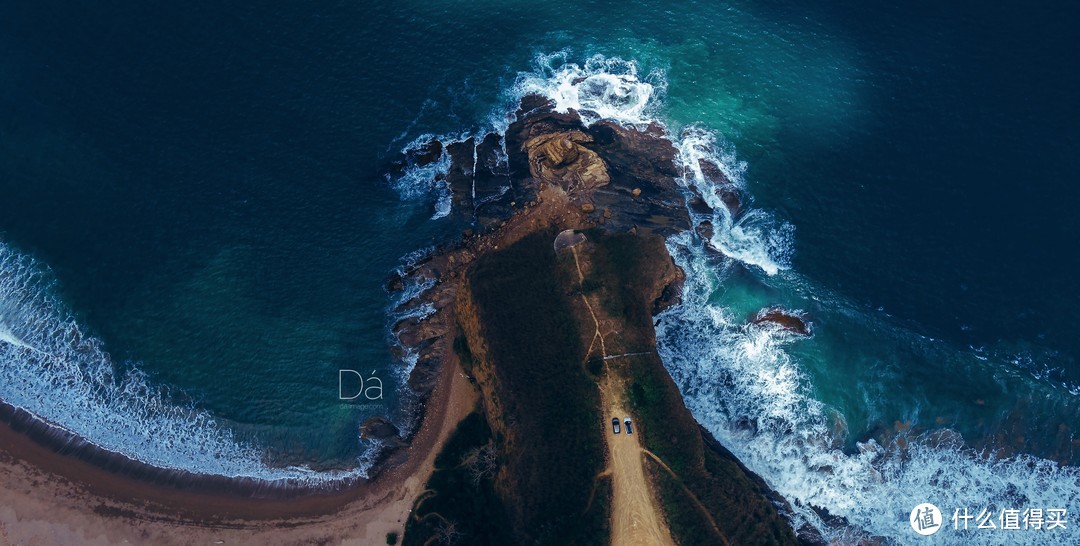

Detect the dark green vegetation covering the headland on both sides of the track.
[{"left": 438, "top": 230, "right": 796, "bottom": 545}]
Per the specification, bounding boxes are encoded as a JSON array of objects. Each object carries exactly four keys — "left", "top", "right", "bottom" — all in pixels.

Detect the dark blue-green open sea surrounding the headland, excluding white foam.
[{"left": 0, "top": 1, "right": 1080, "bottom": 541}]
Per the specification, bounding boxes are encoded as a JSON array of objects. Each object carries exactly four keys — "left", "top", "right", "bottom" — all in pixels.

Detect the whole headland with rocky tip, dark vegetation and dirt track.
[{"left": 391, "top": 96, "right": 800, "bottom": 544}]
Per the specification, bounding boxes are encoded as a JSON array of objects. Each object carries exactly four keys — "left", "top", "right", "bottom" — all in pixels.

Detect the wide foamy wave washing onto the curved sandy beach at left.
[{"left": 0, "top": 243, "right": 367, "bottom": 488}]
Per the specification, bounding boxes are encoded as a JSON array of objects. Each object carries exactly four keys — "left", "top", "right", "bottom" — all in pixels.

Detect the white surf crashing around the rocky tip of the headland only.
[{"left": 390, "top": 51, "right": 795, "bottom": 275}]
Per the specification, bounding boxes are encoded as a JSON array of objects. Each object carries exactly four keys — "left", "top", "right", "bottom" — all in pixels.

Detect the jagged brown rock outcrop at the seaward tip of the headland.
[{"left": 391, "top": 95, "right": 691, "bottom": 235}]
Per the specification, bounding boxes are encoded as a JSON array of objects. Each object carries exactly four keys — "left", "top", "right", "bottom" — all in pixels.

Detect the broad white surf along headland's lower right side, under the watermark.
[{"left": 657, "top": 234, "right": 1080, "bottom": 545}]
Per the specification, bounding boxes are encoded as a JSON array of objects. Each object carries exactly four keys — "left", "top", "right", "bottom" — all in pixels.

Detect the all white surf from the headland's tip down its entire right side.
[{"left": 390, "top": 51, "right": 1080, "bottom": 544}]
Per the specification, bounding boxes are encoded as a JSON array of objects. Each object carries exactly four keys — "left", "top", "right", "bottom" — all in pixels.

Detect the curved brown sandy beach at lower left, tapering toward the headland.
[{"left": 0, "top": 345, "right": 476, "bottom": 544}]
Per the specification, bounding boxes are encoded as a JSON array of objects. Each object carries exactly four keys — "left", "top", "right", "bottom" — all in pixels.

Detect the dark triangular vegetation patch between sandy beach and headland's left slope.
[{"left": 401, "top": 412, "right": 513, "bottom": 546}]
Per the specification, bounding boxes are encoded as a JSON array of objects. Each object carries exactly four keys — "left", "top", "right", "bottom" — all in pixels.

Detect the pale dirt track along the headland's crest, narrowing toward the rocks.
[{"left": 570, "top": 246, "right": 675, "bottom": 546}]
